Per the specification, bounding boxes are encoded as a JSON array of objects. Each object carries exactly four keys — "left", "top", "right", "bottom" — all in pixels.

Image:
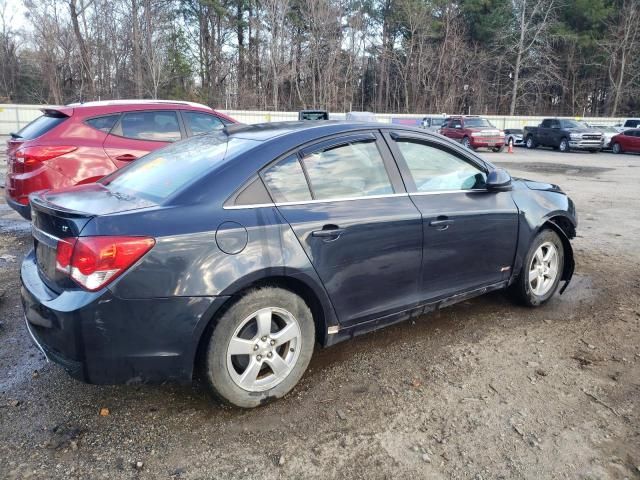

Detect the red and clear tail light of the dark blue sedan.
[{"left": 56, "top": 237, "right": 156, "bottom": 292}]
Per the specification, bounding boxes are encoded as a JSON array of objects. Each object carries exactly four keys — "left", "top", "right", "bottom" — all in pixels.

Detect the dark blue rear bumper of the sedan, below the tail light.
[{"left": 21, "top": 252, "right": 225, "bottom": 384}]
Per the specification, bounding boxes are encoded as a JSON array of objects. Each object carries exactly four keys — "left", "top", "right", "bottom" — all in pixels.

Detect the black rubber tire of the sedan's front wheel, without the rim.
[{"left": 510, "top": 229, "right": 564, "bottom": 307}]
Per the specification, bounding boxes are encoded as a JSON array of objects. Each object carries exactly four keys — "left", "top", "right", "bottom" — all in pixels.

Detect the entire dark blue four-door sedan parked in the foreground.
[{"left": 21, "top": 122, "right": 576, "bottom": 407}]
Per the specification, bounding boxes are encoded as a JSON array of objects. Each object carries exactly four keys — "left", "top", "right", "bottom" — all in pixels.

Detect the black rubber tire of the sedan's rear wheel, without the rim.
[{"left": 203, "top": 287, "right": 315, "bottom": 408}]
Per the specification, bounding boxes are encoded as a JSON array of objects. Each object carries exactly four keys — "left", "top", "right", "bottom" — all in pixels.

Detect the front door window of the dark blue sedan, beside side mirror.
[{"left": 396, "top": 139, "right": 486, "bottom": 192}]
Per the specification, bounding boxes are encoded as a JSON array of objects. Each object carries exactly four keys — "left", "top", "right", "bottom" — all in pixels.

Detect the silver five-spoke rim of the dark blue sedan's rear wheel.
[{"left": 227, "top": 307, "right": 302, "bottom": 392}]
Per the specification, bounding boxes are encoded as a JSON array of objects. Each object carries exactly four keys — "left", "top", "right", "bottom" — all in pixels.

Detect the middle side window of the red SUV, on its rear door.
[{"left": 118, "top": 111, "right": 182, "bottom": 142}]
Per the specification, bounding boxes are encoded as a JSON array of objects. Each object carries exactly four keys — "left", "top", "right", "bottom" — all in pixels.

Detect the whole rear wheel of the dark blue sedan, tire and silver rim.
[{"left": 204, "top": 287, "right": 315, "bottom": 408}]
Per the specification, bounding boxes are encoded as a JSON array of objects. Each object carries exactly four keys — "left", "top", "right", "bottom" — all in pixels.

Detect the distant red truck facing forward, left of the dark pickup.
[{"left": 440, "top": 116, "right": 504, "bottom": 152}]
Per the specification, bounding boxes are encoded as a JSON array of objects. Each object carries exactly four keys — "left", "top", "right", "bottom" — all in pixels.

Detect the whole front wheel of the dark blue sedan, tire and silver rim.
[{"left": 511, "top": 229, "right": 564, "bottom": 307}]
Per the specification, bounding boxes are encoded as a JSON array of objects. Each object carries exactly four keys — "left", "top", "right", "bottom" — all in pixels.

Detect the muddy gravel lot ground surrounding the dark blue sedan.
[{"left": 0, "top": 149, "right": 640, "bottom": 479}]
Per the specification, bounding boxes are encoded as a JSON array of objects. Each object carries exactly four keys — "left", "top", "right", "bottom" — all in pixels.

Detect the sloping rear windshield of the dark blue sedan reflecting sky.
[{"left": 101, "top": 132, "right": 258, "bottom": 203}]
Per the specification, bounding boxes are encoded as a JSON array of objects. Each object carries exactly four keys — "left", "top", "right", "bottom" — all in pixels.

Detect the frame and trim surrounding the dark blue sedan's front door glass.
[{"left": 385, "top": 129, "right": 489, "bottom": 195}]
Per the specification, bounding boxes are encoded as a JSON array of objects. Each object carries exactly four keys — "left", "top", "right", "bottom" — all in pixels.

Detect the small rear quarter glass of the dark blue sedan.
[{"left": 262, "top": 155, "right": 311, "bottom": 203}]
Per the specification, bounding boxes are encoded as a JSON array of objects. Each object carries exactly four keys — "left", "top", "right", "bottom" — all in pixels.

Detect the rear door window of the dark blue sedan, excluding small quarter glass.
[{"left": 302, "top": 141, "right": 393, "bottom": 200}]
